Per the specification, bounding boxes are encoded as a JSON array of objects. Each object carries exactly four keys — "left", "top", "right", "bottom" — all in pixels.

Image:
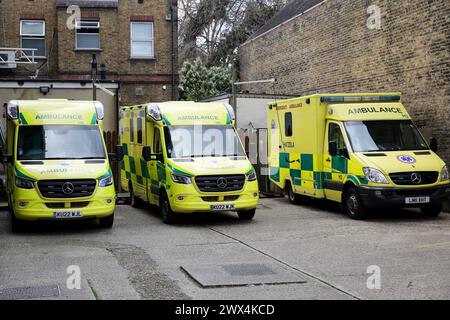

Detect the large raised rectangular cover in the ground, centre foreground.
[{"left": 181, "top": 263, "right": 306, "bottom": 288}]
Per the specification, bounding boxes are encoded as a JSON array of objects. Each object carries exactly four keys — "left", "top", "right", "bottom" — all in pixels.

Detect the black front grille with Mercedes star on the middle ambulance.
[{"left": 195, "top": 174, "right": 245, "bottom": 192}]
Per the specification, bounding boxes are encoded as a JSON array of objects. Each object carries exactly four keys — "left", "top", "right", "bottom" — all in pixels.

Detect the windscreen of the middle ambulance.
[{"left": 164, "top": 125, "right": 245, "bottom": 158}]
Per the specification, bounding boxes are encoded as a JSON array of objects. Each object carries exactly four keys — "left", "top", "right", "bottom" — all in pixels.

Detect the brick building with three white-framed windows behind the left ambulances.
[{"left": 0, "top": 0, "right": 178, "bottom": 131}]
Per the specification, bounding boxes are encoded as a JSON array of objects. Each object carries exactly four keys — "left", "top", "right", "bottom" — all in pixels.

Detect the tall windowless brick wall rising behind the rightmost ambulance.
[{"left": 240, "top": 0, "right": 450, "bottom": 163}]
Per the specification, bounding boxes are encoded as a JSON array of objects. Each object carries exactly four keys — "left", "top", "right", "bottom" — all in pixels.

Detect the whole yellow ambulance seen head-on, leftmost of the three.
[{"left": 1, "top": 99, "right": 116, "bottom": 230}]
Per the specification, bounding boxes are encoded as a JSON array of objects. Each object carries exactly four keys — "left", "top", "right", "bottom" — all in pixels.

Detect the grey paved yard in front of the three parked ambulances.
[{"left": 0, "top": 199, "right": 450, "bottom": 300}]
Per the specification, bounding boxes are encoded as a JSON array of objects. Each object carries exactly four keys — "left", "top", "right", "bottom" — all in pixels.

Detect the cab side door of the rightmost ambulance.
[{"left": 323, "top": 122, "right": 349, "bottom": 202}]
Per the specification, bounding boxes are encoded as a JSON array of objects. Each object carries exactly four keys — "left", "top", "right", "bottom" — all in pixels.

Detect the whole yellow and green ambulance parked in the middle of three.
[{"left": 119, "top": 102, "right": 259, "bottom": 224}]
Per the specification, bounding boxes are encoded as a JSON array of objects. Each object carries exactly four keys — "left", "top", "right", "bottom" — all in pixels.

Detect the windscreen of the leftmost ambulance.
[{"left": 17, "top": 125, "right": 106, "bottom": 160}]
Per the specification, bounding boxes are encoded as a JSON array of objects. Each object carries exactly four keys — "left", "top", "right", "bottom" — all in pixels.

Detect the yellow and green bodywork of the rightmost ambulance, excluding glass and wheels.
[{"left": 268, "top": 93, "right": 450, "bottom": 208}]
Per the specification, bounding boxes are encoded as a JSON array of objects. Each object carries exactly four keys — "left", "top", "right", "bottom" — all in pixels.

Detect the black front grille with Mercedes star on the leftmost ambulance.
[{"left": 38, "top": 179, "right": 97, "bottom": 198}]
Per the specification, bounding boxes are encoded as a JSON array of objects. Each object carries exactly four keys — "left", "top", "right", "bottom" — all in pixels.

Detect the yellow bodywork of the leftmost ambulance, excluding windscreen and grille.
[{"left": 5, "top": 99, "right": 116, "bottom": 220}]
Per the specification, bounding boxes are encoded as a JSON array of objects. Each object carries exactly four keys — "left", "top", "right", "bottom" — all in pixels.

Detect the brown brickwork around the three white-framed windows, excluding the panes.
[{"left": 0, "top": 0, "right": 178, "bottom": 105}]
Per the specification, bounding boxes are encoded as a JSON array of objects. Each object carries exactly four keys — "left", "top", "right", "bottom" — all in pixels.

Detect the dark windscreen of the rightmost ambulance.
[{"left": 345, "top": 120, "right": 428, "bottom": 152}]
